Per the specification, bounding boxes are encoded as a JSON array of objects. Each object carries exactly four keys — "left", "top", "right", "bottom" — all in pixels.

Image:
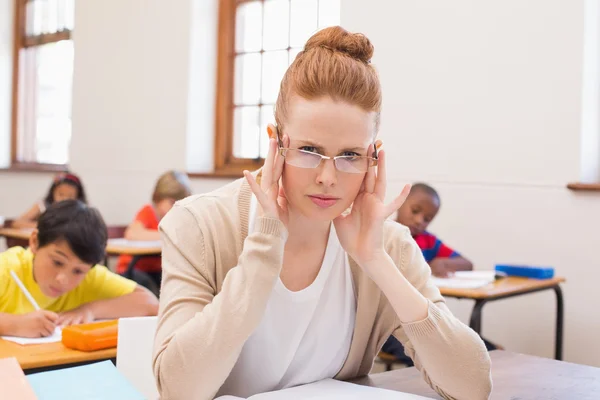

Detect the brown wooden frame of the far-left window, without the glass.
[{"left": 8, "top": 0, "right": 72, "bottom": 172}]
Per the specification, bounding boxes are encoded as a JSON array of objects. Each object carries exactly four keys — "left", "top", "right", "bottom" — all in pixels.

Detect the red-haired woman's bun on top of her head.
[{"left": 304, "top": 26, "right": 375, "bottom": 63}]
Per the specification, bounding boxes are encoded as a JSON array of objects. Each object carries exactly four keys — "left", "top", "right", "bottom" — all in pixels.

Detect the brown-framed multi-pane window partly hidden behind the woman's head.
[{"left": 215, "top": 0, "right": 340, "bottom": 174}]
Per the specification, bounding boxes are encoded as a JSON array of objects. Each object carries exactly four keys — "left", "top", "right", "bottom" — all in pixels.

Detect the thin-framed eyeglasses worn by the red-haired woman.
[{"left": 279, "top": 147, "right": 377, "bottom": 174}]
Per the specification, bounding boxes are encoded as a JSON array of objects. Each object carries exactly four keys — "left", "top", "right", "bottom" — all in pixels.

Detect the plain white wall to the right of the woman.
[{"left": 342, "top": 0, "right": 600, "bottom": 366}]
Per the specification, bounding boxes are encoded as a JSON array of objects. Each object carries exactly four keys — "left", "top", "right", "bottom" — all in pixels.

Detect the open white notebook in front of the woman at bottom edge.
[{"left": 215, "top": 379, "right": 428, "bottom": 400}]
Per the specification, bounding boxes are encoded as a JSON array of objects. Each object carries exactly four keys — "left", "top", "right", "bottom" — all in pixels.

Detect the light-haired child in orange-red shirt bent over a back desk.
[{"left": 117, "top": 171, "right": 191, "bottom": 287}]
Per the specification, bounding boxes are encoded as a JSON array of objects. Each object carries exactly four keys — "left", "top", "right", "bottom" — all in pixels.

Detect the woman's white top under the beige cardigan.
[{"left": 217, "top": 196, "right": 356, "bottom": 397}]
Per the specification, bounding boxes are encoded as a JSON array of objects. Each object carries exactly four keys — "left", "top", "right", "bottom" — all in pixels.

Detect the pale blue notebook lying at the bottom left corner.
[{"left": 27, "top": 361, "right": 145, "bottom": 400}]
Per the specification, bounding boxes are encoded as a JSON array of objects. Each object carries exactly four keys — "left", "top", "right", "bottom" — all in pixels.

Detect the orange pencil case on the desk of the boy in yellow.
[{"left": 62, "top": 319, "right": 119, "bottom": 351}]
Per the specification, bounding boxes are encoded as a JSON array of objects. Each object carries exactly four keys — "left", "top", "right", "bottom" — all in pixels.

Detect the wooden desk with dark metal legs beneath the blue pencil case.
[{"left": 440, "top": 276, "right": 565, "bottom": 360}]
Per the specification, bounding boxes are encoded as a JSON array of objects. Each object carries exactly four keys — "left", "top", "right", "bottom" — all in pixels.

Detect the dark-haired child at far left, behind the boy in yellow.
[{"left": 12, "top": 172, "right": 87, "bottom": 228}]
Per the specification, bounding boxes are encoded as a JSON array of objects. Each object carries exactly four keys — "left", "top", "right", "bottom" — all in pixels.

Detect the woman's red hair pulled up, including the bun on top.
[{"left": 275, "top": 26, "right": 381, "bottom": 132}]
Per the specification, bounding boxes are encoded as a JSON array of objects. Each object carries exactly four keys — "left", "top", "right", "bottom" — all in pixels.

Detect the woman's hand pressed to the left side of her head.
[{"left": 244, "top": 135, "right": 289, "bottom": 226}]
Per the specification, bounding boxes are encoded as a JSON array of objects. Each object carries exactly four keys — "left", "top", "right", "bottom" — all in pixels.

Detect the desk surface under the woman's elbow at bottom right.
[{"left": 351, "top": 350, "right": 600, "bottom": 400}]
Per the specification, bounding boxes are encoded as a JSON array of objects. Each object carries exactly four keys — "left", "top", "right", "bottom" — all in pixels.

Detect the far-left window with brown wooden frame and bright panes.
[{"left": 11, "top": 0, "right": 74, "bottom": 169}]
